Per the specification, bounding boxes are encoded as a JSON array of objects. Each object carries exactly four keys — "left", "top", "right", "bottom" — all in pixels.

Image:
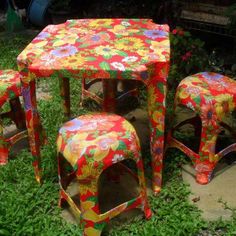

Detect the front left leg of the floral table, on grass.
[{"left": 22, "top": 80, "right": 42, "bottom": 183}]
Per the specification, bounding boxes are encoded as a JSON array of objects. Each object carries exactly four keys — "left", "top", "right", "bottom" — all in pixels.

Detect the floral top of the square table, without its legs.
[{"left": 17, "top": 19, "right": 170, "bottom": 80}]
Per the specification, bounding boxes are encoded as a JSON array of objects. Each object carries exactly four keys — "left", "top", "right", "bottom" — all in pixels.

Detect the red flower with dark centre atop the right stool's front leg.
[{"left": 201, "top": 103, "right": 217, "bottom": 127}]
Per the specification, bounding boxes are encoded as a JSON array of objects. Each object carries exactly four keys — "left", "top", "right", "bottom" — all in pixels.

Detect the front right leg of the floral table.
[{"left": 148, "top": 78, "right": 166, "bottom": 195}]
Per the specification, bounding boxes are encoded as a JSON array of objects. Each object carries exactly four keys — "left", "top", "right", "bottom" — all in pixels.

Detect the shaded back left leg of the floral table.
[{"left": 59, "top": 77, "right": 71, "bottom": 119}]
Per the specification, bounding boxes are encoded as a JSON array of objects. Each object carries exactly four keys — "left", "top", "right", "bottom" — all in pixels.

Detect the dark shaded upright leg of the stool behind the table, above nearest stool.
[{"left": 102, "top": 79, "right": 117, "bottom": 113}]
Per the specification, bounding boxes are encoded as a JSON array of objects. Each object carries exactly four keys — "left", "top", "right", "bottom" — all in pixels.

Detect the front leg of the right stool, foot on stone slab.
[{"left": 195, "top": 125, "right": 220, "bottom": 184}]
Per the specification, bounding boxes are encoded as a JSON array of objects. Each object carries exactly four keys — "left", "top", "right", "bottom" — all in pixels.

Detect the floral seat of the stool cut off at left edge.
[{"left": 0, "top": 70, "right": 21, "bottom": 106}]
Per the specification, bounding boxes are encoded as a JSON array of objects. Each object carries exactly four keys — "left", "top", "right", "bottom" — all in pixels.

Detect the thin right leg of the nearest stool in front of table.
[{"left": 137, "top": 157, "right": 152, "bottom": 219}]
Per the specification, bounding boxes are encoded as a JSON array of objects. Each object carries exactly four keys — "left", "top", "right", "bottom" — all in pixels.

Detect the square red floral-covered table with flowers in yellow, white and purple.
[{"left": 17, "top": 19, "right": 170, "bottom": 193}]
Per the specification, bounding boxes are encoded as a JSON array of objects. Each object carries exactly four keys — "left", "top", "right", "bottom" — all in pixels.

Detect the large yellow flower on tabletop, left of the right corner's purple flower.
[{"left": 115, "top": 37, "right": 144, "bottom": 51}]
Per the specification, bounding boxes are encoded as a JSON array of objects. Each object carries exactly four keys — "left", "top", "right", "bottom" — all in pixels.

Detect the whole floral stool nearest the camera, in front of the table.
[{"left": 57, "top": 113, "right": 151, "bottom": 236}]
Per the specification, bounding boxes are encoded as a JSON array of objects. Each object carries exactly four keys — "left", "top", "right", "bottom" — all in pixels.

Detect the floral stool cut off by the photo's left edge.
[{"left": 0, "top": 70, "right": 27, "bottom": 165}]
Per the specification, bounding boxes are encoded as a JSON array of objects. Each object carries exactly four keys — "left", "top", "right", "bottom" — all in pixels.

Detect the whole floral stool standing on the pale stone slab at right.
[{"left": 167, "top": 72, "right": 236, "bottom": 184}]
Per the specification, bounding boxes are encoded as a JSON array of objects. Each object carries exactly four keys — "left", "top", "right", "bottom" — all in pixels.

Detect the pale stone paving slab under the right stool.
[{"left": 182, "top": 163, "right": 236, "bottom": 221}]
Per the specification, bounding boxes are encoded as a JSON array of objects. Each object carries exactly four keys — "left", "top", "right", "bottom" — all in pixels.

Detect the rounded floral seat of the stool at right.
[{"left": 176, "top": 72, "right": 236, "bottom": 122}]
